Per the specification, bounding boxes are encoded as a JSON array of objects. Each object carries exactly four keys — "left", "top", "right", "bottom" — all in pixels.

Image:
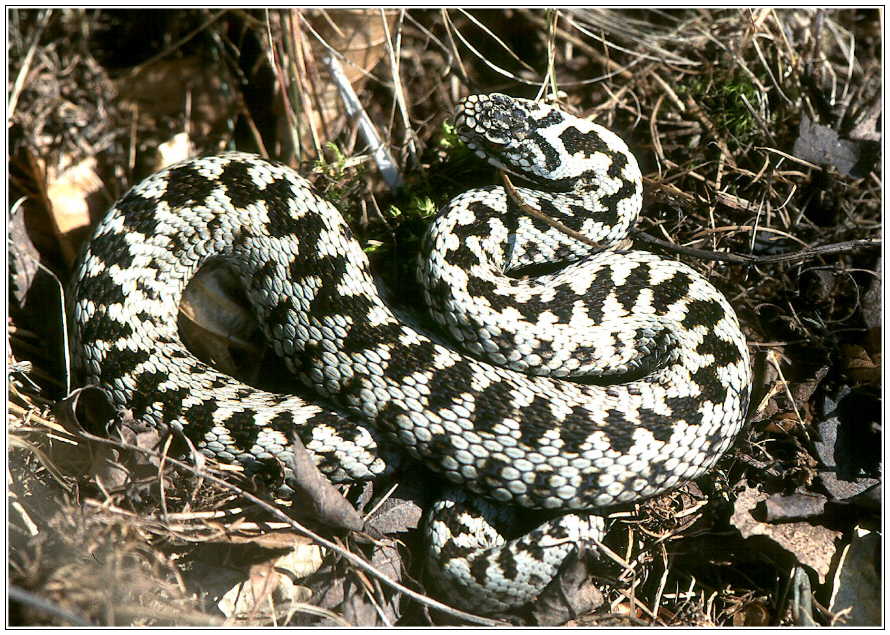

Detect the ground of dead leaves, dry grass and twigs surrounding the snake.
[{"left": 7, "top": 8, "right": 883, "bottom": 626}]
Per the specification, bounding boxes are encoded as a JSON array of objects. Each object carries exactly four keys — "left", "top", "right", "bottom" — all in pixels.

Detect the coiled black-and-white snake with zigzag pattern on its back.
[{"left": 69, "top": 93, "right": 751, "bottom": 614}]
